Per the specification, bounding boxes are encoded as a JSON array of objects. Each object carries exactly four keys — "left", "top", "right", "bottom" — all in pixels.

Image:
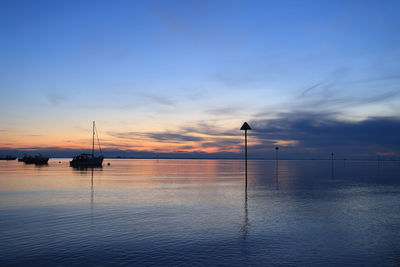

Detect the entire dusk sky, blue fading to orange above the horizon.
[{"left": 0, "top": 0, "right": 400, "bottom": 158}]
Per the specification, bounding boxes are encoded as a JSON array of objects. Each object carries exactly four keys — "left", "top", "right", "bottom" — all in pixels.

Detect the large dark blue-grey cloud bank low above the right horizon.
[{"left": 251, "top": 113, "right": 400, "bottom": 158}]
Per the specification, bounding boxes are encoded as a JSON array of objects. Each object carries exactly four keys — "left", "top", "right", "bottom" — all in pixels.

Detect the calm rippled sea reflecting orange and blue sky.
[{"left": 0, "top": 160, "right": 400, "bottom": 266}]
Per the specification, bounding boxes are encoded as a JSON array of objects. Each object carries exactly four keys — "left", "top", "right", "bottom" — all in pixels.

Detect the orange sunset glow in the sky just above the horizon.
[{"left": 0, "top": 126, "right": 299, "bottom": 153}]
